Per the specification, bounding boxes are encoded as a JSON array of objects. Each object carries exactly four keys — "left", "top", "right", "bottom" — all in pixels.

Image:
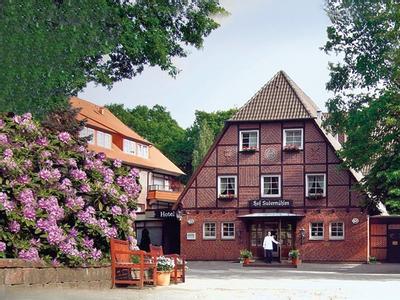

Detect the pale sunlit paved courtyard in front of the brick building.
[{"left": 0, "top": 262, "right": 400, "bottom": 300}]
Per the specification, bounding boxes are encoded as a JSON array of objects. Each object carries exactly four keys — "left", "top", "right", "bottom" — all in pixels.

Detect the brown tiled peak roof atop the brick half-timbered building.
[{"left": 229, "top": 71, "right": 318, "bottom": 121}]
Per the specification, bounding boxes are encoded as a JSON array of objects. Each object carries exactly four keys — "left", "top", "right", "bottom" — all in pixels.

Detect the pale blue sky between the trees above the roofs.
[{"left": 79, "top": 0, "right": 335, "bottom": 128}]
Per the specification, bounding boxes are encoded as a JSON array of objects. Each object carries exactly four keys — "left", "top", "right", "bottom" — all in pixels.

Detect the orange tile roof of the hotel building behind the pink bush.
[{"left": 70, "top": 97, "right": 184, "bottom": 176}]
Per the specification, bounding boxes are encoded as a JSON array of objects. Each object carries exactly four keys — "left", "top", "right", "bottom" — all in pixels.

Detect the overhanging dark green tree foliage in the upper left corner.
[{"left": 0, "top": 0, "right": 224, "bottom": 116}]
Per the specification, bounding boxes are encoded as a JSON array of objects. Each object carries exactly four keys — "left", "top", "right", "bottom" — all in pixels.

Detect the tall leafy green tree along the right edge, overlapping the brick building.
[{"left": 323, "top": 0, "right": 400, "bottom": 213}]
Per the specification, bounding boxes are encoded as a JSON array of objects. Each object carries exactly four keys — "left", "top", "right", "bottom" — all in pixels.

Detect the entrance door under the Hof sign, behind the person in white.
[{"left": 250, "top": 222, "right": 280, "bottom": 260}]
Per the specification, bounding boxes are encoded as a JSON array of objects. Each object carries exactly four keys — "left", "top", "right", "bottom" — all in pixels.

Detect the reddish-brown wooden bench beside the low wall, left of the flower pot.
[{"left": 110, "top": 239, "right": 157, "bottom": 288}]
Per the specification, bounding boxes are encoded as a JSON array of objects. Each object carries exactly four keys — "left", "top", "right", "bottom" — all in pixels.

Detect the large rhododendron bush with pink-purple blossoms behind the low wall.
[{"left": 0, "top": 114, "right": 141, "bottom": 265}]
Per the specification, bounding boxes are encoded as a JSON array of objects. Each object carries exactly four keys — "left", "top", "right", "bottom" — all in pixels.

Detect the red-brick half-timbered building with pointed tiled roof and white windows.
[{"left": 178, "top": 71, "right": 369, "bottom": 261}]
